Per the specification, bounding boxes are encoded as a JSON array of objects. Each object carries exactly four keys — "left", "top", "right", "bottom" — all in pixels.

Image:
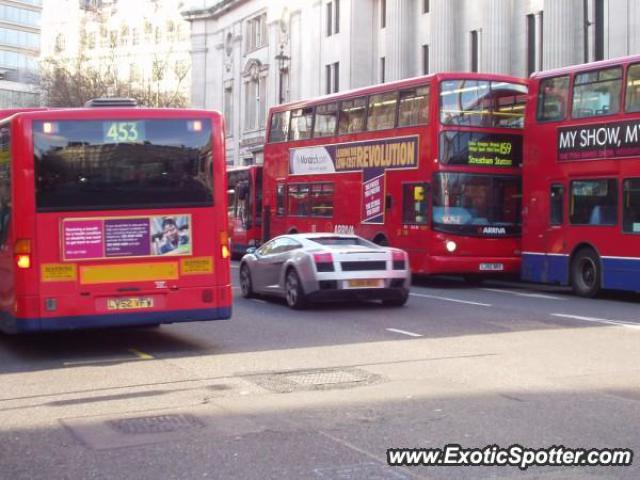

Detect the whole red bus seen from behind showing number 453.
[{"left": 0, "top": 102, "right": 231, "bottom": 333}]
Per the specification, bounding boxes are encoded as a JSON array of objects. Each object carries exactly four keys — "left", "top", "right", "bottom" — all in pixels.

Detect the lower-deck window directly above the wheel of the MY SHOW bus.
[{"left": 569, "top": 179, "right": 618, "bottom": 225}]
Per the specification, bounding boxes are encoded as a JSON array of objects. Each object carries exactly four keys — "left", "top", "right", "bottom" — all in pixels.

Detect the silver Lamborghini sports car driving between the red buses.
[{"left": 240, "top": 233, "right": 411, "bottom": 309}]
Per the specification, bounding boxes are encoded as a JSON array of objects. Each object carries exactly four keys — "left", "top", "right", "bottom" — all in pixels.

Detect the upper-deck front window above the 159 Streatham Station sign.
[{"left": 440, "top": 80, "right": 527, "bottom": 128}]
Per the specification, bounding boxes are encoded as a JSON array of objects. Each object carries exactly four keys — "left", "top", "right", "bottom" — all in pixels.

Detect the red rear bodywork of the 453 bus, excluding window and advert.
[{"left": 0, "top": 108, "right": 232, "bottom": 333}]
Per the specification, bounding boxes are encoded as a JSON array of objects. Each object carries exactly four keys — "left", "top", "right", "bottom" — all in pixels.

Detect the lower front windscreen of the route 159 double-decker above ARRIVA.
[{"left": 433, "top": 173, "right": 522, "bottom": 237}]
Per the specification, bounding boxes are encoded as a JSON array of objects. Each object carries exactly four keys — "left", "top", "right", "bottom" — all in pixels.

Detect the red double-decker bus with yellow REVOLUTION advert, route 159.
[{"left": 263, "top": 73, "right": 527, "bottom": 279}]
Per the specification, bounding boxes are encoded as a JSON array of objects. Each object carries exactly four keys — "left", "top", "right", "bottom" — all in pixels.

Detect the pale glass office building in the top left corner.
[{"left": 0, "top": 0, "right": 42, "bottom": 108}]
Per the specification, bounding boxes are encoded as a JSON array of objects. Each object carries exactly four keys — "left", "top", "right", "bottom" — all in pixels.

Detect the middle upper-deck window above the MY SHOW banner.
[{"left": 572, "top": 67, "right": 622, "bottom": 118}]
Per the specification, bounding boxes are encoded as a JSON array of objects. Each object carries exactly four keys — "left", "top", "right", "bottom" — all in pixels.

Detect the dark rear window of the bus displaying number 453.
[{"left": 33, "top": 119, "right": 213, "bottom": 212}]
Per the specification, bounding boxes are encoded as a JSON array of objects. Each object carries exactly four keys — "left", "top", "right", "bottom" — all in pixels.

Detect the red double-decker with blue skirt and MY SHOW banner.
[{"left": 522, "top": 55, "right": 640, "bottom": 297}]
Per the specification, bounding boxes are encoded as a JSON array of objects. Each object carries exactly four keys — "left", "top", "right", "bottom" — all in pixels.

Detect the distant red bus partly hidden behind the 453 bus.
[{"left": 227, "top": 165, "right": 262, "bottom": 257}]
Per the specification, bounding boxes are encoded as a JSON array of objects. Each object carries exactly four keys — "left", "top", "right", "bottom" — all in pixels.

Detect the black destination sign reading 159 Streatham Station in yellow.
[{"left": 440, "top": 131, "right": 522, "bottom": 168}]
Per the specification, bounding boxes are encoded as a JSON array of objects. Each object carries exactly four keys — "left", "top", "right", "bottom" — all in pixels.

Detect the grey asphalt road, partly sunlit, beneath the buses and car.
[{"left": 0, "top": 269, "right": 640, "bottom": 480}]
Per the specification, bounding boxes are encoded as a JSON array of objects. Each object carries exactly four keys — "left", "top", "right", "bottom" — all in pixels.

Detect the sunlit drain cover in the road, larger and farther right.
[{"left": 246, "top": 368, "right": 381, "bottom": 393}]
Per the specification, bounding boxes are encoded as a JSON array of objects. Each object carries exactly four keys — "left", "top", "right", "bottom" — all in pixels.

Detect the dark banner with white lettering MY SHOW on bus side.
[{"left": 558, "top": 121, "right": 640, "bottom": 162}]
